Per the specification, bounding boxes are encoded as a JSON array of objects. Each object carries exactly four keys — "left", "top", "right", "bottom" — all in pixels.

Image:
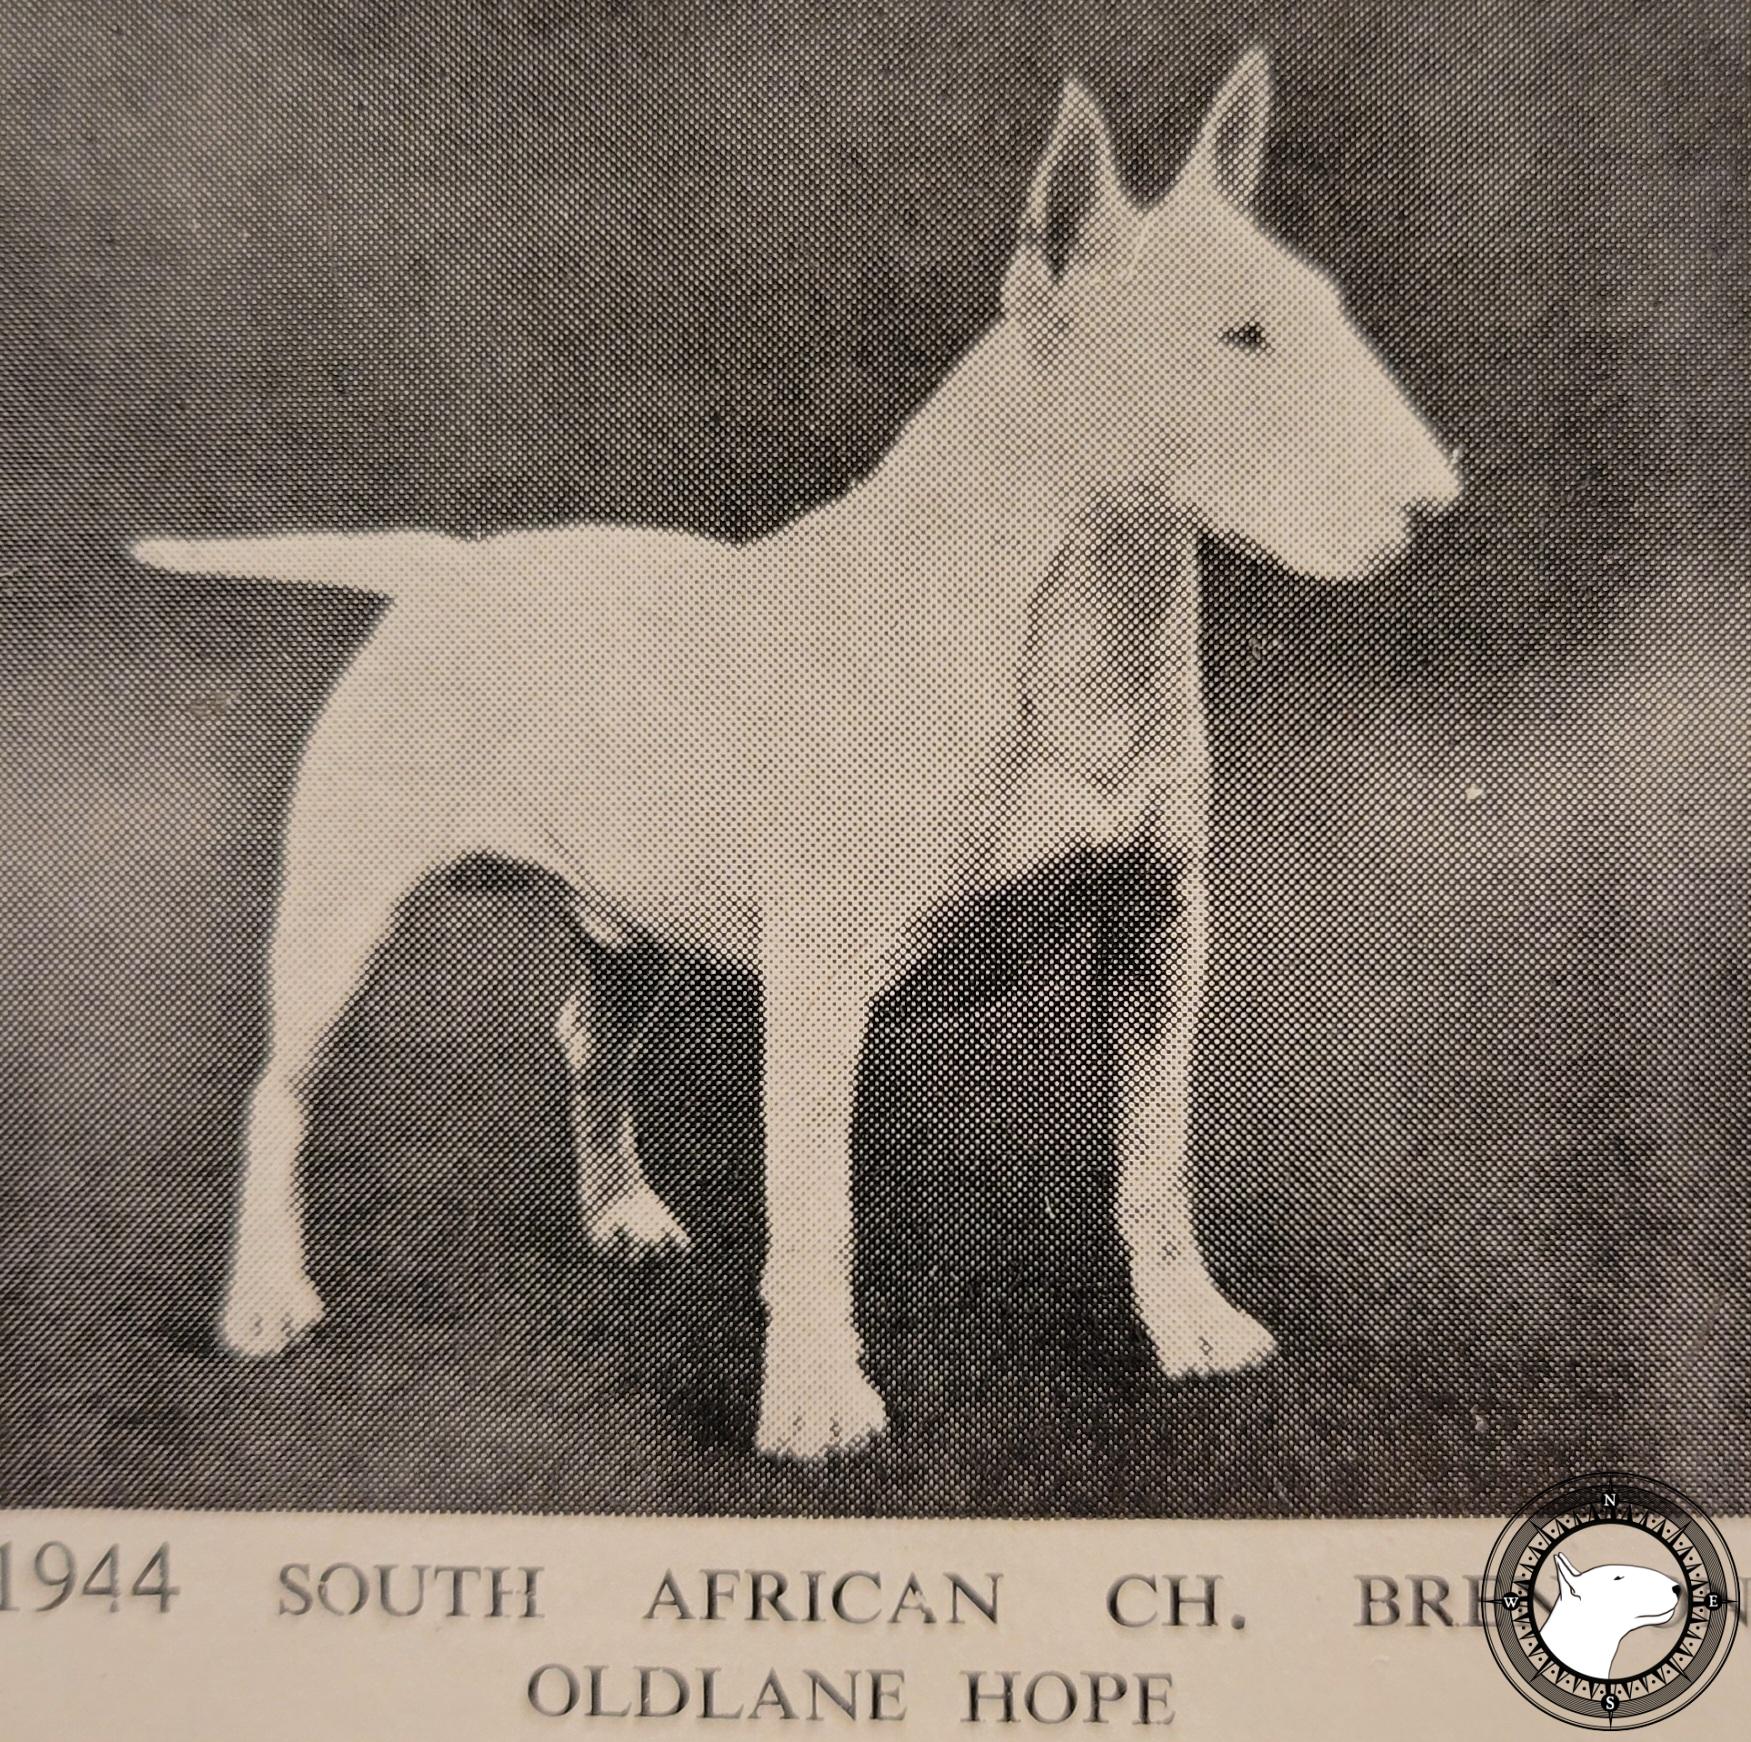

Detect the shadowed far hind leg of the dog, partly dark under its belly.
[{"left": 555, "top": 914, "right": 688, "bottom": 1257}]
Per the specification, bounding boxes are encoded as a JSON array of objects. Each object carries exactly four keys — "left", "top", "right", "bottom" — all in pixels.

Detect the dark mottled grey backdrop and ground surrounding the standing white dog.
[{"left": 0, "top": 0, "right": 1751, "bottom": 1514}]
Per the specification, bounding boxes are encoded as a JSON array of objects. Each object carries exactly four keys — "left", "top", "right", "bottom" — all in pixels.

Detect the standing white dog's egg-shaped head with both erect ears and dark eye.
[{"left": 1003, "top": 51, "right": 1459, "bottom": 579}]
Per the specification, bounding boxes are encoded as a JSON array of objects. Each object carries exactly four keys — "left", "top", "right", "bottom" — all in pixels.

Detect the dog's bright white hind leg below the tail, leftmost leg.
[{"left": 221, "top": 823, "right": 444, "bottom": 1357}]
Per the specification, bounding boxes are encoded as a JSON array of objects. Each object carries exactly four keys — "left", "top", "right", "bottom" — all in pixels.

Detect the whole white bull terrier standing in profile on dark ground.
[{"left": 137, "top": 51, "right": 1457, "bottom": 1457}]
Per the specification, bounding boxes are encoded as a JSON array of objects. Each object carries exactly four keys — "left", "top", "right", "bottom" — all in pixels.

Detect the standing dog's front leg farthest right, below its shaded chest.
[{"left": 1114, "top": 860, "right": 1276, "bottom": 1374}]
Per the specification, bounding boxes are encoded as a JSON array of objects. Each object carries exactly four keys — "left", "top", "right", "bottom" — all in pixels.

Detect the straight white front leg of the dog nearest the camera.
[{"left": 755, "top": 928, "right": 886, "bottom": 1458}]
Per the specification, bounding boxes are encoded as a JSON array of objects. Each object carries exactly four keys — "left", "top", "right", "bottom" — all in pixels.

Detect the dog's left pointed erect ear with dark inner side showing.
[{"left": 1003, "top": 79, "right": 1135, "bottom": 325}]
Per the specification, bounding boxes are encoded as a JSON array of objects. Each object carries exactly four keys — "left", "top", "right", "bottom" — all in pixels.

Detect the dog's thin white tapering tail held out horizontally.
[{"left": 131, "top": 532, "right": 462, "bottom": 599}]
